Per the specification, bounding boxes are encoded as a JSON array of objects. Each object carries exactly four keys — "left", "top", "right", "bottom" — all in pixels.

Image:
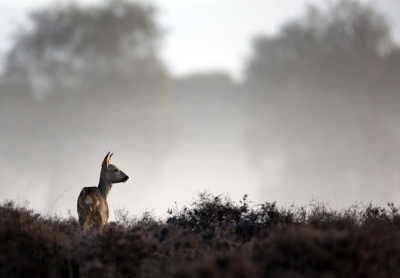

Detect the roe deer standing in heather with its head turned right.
[{"left": 78, "top": 152, "right": 129, "bottom": 236}]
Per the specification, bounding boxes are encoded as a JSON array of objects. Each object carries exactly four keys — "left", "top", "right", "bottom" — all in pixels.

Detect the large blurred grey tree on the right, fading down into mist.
[{"left": 246, "top": 1, "right": 400, "bottom": 204}]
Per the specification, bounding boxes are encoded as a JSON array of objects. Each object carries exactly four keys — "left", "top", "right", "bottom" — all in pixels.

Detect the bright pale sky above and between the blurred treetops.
[{"left": 0, "top": 0, "right": 400, "bottom": 79}]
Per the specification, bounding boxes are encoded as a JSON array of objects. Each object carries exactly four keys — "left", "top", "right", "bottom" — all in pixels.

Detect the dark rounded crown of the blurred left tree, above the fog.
[{"left": 5, "top": 0, "right": 166, "bottom": 101}]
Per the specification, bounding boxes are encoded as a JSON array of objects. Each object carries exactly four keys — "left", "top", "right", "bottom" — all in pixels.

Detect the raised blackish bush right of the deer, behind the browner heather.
[{"left": 166, "top": 192, "right": 295, "bottom": 240}]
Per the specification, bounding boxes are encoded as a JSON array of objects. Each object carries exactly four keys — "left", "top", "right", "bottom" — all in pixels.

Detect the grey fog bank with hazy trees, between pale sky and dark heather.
[{"left": 0, "top": 1, "right": 400, "bottom": 219}]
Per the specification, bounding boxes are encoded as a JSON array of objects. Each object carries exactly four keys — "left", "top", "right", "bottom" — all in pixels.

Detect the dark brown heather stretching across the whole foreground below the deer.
[{"left": 0, "top": 193, "right": 400, "bottom": 277}]
